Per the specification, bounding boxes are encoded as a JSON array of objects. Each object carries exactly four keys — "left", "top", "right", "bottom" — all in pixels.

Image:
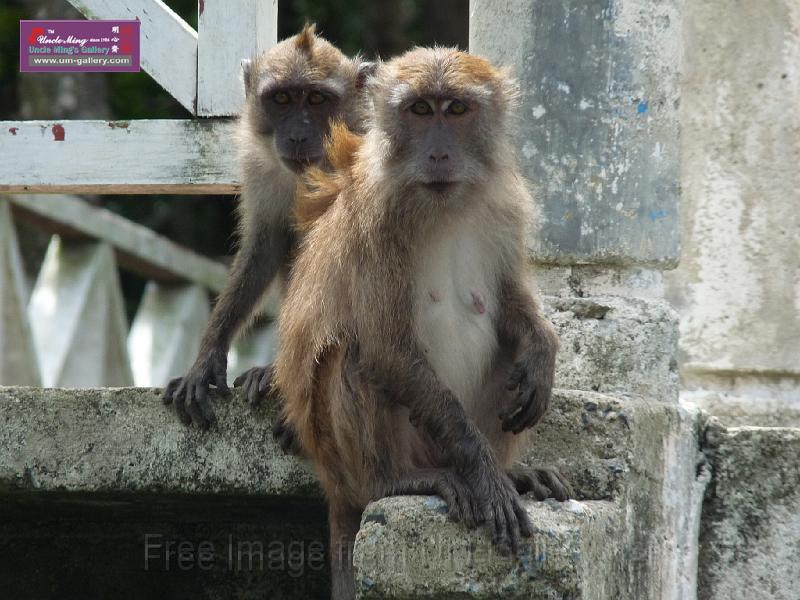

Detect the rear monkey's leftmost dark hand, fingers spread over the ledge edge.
[{"left": 161, "top": 349, "right": 230, "bottom": 429}]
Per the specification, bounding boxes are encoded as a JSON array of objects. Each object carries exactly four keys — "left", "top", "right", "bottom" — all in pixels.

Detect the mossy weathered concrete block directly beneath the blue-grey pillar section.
[{"left": 542, "top": 296, "right": 678, "bottom": 402}]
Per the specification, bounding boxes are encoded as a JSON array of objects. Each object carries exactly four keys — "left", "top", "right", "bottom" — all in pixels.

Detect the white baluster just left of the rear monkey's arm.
[{"left": 128, "top": 281, "right": 209, "bottom": 387}]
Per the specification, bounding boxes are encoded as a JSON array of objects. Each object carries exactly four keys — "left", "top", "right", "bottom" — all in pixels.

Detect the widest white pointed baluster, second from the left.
[{"left": 28, "top": 236, "right": 133, "bottom": 387}]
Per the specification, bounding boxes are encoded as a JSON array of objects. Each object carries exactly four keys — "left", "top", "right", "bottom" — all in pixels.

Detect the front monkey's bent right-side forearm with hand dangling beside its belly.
[{"left": 497, "top": 280, "right": 558, "bottom": 434}]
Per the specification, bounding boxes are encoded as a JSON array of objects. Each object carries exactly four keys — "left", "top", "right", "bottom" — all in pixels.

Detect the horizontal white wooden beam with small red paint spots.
[{"left": 0, "top": 119, "right": 239, "bottom": 194}]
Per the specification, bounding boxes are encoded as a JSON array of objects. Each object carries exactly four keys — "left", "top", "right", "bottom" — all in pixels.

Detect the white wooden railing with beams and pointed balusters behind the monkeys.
[{"left": 0, "top": 0, "right": 277, "bottom": 386}]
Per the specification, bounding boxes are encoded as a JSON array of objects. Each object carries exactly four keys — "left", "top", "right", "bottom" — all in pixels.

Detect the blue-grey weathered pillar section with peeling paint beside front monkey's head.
[{"left": 470, "top": 0, "right": 683, "bottom": 266}]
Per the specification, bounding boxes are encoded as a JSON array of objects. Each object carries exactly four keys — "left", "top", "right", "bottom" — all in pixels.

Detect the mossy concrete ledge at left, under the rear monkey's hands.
[{"left": 0, "top": 387, "right": 318, "bottom": 495}]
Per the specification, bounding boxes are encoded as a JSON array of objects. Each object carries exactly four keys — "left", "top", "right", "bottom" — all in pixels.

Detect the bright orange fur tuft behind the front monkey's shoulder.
[{"left": 295, "top": 121, "right": 363, "bottom": 233}]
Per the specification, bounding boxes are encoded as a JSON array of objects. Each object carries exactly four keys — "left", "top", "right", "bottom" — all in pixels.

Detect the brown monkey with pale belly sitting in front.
[{"left": 274, "top": 48, "right": 570, "bottom": 598}]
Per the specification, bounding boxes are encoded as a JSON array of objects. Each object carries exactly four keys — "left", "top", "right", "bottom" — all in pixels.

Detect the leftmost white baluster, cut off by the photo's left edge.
[{"left": 0, "top": 200, "right": 40, "bottom": 385}]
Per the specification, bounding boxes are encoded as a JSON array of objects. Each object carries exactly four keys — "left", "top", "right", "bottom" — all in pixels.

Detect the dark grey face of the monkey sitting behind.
[{"left": 261, "top": 86, "right": 340, "bottom": 173}]
